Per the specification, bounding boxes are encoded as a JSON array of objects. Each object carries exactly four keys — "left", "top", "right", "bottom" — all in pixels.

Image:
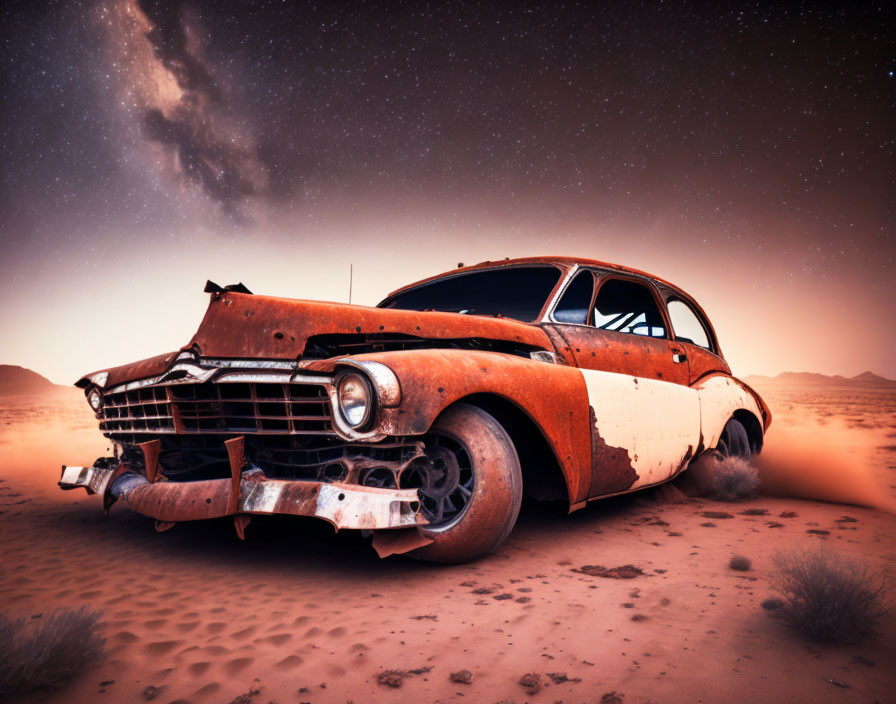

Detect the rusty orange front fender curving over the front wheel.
[{"left": 327, "top": 349, "right": 591, "bottom": 504}]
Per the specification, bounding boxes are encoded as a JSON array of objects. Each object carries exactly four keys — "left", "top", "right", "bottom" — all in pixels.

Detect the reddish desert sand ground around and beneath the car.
[{"left": 0, "top": 389, "right": 896, "bottom": 704}]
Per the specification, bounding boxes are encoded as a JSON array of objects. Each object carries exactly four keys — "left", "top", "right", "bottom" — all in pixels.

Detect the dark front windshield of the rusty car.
[{"left": 378, "top": 265, "right": 560, "bottom": 322}]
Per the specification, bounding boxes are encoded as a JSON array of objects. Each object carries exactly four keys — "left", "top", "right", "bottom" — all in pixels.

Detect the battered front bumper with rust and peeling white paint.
[{"left": 59, "top": 465, "right": 429, "bottom": 530}]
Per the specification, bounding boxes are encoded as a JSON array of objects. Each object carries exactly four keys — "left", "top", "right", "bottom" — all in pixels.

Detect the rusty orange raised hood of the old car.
[{"left": 76, "top": 291, "right": 553, "bottom": 387}]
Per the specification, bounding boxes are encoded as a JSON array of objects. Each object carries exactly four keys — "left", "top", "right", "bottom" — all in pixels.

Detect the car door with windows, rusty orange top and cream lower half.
[{"left": 546, "top": 269, "right": 700, "bottom": 498}]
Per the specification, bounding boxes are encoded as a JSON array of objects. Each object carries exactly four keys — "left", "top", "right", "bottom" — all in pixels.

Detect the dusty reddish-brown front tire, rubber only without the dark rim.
[{"left": 409, "top": 403, "right": 523, "bottom": 562}]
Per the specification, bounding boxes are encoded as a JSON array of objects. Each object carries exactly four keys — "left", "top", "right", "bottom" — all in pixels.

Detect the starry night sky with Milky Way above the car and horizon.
[{"left": 0, "top": 0, "right": 896, "bottom": 383}]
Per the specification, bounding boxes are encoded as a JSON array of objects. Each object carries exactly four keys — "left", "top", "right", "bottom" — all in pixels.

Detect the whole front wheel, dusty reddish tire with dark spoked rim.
[{"left": 410, "top": 403, "right": 523, "bottom": 562}]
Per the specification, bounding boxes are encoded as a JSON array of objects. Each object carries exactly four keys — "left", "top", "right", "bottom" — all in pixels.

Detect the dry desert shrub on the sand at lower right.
[{"left": 769, "top": 548, "right": 886, "bottom": 643}]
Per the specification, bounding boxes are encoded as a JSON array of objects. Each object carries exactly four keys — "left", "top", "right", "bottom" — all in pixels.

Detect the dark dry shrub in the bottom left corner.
[{"left": 0, "top": 607, "right": 106, "bottom": 700}]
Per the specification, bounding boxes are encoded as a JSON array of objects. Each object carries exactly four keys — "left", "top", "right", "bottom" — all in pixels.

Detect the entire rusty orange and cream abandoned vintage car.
[{"left": 59, "top": 257, "right": 771, "bottom": 562}]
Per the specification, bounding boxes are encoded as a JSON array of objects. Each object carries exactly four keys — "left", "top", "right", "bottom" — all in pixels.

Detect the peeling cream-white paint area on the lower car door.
[{"left": 581, "top": 369, "right": 700, "bottom": 491}]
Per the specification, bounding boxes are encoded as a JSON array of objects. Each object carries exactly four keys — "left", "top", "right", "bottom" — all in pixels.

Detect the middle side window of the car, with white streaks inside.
[{"left": 594, "top": 279, "right": 666, "bottom": 337}]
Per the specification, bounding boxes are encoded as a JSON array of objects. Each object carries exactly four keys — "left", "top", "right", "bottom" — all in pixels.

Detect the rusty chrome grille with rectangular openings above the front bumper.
[{"left": 100, "top": 382, "right": 332, "bottom": 435}]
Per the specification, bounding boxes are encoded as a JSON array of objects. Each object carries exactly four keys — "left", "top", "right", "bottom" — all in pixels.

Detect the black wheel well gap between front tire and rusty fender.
[{"left": 448, "top": 394, "right": 569, "bottom": 501}]
